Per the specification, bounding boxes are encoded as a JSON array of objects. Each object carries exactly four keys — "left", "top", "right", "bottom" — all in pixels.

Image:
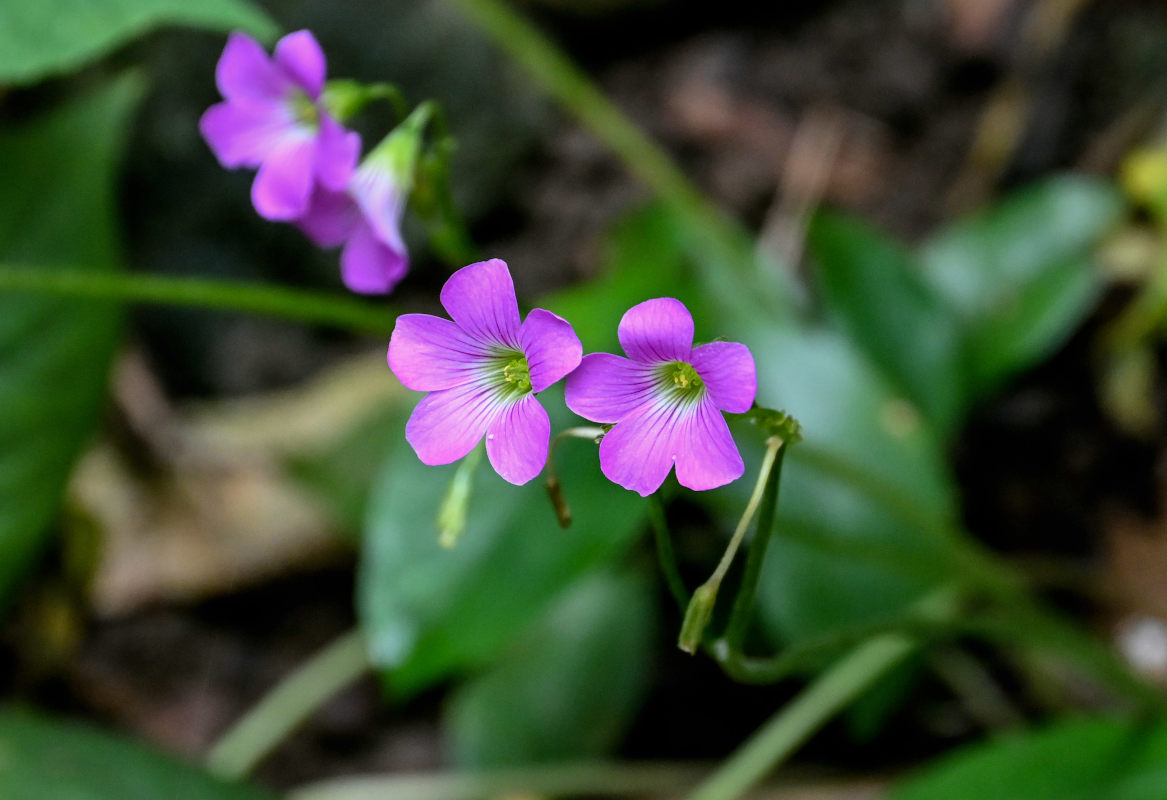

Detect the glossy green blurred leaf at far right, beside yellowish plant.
[{"left": 921, "top": 176, "right": 1121, "bottom": 397}]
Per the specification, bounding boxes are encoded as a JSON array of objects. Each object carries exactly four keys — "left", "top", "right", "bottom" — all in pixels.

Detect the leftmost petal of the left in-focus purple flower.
[{"left": 389, "top": 314, "right": 487, "bottom": 392}]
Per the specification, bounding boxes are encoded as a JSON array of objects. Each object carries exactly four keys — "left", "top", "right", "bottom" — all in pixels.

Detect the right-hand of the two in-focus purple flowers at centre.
[{"left": 567, "top": 297, "right": 757, "bottom": 497}]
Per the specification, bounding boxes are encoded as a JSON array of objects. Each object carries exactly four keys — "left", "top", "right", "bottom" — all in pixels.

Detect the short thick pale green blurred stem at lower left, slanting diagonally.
[{"left": 207, "top": 630, "right": 369, "bottom": 780}]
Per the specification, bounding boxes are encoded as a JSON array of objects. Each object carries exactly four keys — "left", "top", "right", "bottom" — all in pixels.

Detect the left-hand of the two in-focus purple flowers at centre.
[{"left": 389, "top": 259, "right": 582, "bottom": 484}]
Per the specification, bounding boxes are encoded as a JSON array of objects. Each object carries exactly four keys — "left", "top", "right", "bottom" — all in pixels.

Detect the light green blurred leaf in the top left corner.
[{"left": 0, "top": 0, "right": 279, "bottom": 85}]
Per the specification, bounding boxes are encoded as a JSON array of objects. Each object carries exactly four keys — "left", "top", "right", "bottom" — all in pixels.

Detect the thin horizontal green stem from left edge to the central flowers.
[{"left": 0, "top": 265, "right": 397, "bottom": 335}]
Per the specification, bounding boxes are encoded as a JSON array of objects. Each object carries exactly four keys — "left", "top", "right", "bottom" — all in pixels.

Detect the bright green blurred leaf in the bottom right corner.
[{"left": 888, "top": 720, "right": 1167, "bottom": 800}]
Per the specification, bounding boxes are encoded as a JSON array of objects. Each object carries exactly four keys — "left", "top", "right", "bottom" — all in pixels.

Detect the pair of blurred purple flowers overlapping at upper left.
[{"left": 198, "top": 30, "right": 418, "bottom": 294}]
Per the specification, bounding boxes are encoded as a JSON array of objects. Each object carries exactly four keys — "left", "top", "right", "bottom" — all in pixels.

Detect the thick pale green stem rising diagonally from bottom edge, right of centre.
[{"left": 689, "top": 587, "right": 959, "bottom": 800}]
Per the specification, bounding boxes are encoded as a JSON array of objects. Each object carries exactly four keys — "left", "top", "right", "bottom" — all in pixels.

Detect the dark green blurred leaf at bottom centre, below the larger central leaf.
[{"left": 446, "top": 573, "right": 655, "bottom": 766}]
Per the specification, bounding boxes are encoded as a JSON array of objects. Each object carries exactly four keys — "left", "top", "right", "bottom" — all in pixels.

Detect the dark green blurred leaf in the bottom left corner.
[{"left": 0, "top": 710, "right": 272, "bottom": 800}]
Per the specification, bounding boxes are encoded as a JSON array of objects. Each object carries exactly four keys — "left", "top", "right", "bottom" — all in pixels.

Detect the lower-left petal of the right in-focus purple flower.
[{"left": 600, "top": 402, "right": 692, "bottom": 497}]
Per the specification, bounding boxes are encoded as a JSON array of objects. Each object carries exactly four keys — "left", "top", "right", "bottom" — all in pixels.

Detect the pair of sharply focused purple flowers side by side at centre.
[{"left": 389, "top": 259, "right": 757, "bottom": 496}]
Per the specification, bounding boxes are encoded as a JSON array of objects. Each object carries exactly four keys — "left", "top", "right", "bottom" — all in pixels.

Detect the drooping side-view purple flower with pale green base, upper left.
[{"left": 296, "top": 128, "right": 420, "bottom": 294}]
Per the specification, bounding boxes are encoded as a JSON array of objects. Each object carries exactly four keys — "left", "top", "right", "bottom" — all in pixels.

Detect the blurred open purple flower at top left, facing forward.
[{"left": 198, "top": 30, "right": 361, "bottom": 220}]
